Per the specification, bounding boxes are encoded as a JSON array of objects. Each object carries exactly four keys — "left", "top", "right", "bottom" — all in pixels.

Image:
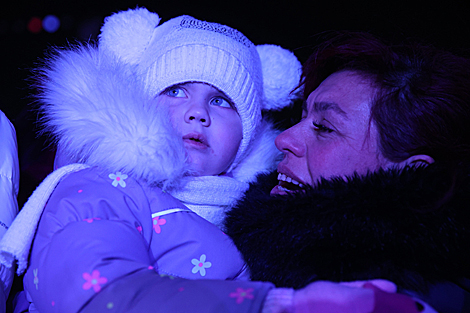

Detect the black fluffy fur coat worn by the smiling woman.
[{"left": 226, "top": 164, "right": 470, "bottom": 292}]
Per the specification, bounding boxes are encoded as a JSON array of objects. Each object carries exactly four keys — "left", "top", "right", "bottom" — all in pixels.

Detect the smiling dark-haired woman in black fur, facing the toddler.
[{"left": 226, "top": 34, "right": 470, "bottom": 312}]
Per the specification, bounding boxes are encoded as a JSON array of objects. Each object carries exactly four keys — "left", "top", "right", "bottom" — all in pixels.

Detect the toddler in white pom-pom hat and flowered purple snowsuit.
[{"left": 0, "top": 8, "right": 300, "bottom": 312}]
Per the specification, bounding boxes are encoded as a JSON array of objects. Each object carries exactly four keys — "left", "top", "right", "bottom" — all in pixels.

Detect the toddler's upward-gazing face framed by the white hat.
[{"left": 158, "top": 83, "right": 243, "bottom": 176}]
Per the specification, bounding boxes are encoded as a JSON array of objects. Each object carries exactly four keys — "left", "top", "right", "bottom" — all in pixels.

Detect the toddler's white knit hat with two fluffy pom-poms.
[{"left": 99, "top": 8, "right": 300, "bottom": 169}]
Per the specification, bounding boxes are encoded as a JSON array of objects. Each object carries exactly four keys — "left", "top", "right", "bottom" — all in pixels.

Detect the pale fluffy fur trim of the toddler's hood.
[{"left": 37, "top": 44, "right": 279, "bottom": 188}]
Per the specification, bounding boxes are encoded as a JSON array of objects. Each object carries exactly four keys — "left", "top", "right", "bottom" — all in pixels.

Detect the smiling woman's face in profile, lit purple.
[{"left": 271, "top": 71, "right": 392, "bottom": 194}]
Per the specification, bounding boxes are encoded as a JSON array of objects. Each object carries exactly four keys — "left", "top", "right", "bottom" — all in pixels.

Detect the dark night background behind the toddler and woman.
[{"left": 0, "top": 0, "right": 470, "bottom": 205}]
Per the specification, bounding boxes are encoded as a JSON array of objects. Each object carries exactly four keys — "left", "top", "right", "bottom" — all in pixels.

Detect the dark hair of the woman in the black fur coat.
[{"left": 301, "top": 33, "right": 470, "bottom": 162}]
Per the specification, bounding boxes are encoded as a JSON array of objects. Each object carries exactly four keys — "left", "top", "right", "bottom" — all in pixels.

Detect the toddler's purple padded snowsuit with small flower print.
[{"left": 24, "top": 167, "right": 273, "bottom": 312}]
